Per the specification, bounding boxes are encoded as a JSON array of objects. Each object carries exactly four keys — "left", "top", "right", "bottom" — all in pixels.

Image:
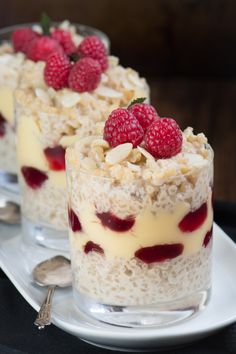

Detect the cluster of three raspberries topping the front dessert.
[{"left": 104, "top": 99, "right": 183, "bottom": 159}]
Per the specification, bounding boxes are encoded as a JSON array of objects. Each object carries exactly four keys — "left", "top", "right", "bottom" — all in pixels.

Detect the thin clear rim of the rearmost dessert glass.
[{"left": 0, "top": 21, "right": 110, "bottom": 50}]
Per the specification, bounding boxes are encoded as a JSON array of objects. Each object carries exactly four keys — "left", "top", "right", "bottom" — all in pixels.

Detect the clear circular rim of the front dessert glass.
[{"left": 66, "top": 142, "right": 214, "bottom": 183}]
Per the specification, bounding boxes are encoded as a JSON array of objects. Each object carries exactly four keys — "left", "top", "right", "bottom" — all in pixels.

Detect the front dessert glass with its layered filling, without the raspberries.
[{"left": 66, "top": 130, "right": 213, "bottom": 327}]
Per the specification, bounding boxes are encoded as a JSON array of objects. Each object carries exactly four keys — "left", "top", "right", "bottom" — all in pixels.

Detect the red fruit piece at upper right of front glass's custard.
[{"left": 179, "top": 203, "right": 207, "bottom": 232}]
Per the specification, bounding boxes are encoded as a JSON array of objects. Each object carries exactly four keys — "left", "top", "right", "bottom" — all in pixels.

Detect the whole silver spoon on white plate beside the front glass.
[{"left": 33, "top": 256, "right": 72, "bottom": 329}]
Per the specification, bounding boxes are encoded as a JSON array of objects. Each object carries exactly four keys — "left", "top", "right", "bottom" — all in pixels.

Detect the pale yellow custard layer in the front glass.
[{"left": 70, "top": 193, "right": 213, "bottom": 259}]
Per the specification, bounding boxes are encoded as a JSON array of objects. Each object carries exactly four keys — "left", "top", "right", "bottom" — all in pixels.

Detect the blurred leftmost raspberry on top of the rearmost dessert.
[{"left": 11, "top": 27, "right": 39, "bottom": 53}]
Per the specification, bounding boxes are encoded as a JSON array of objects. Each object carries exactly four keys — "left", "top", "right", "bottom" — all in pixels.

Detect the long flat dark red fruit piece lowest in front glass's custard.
[{"left": 135, "top": 243, "right": 184, "bottom": 264}]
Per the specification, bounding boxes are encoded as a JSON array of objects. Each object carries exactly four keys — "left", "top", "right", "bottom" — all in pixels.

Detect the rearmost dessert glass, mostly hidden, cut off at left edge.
[{"left": 0, "top": 22, "right": 110, "bottom": 203}]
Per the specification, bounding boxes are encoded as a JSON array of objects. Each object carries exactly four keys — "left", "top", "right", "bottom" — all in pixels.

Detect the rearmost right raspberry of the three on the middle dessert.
[{"left": 78, "top": 36, "right": 108, "bottom": 71}]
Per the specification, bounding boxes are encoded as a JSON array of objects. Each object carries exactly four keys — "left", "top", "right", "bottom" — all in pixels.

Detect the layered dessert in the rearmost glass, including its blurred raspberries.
[{"left": 0, "top": 18, "right": 105, "bottom": 174}]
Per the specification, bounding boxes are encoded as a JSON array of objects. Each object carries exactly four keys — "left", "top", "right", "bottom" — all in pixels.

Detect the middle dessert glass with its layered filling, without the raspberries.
[{"left": 15, "top": 41, "right": 149, "bottom": 250}]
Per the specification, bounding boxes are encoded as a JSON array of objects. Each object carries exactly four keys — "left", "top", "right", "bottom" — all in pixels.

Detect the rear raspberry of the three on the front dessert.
[{"left": 128, "top": 103, "right": 159, "bottom": 132}]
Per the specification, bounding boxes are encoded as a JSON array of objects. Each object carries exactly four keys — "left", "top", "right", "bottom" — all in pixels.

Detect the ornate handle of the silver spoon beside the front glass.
[{"left": 34, "top": 285, "right": 56, "bottom": 329}]
